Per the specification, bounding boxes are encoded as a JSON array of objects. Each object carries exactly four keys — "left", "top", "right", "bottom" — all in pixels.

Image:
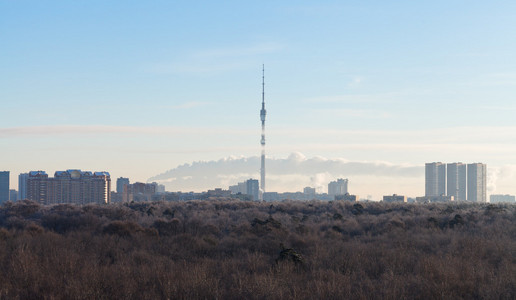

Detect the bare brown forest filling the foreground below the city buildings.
[{"left": 0, "top": 199, "right": 516, "bottom": 299}]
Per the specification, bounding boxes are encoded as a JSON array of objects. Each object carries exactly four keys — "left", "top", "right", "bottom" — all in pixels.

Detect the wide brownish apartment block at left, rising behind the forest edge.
[{"left": 27, "top": 170, "right": 111, "bottom": 204}]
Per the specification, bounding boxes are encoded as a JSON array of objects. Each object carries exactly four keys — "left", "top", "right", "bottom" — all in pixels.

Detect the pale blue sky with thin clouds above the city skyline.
[{"left": 0, "top": 0, "right": 516, "bottom": 199}]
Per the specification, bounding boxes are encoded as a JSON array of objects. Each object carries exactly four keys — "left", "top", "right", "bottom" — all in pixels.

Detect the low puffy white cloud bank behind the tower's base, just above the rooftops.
[{"left": 148, "top": 152, "right": 423, "bottom": 194}]
